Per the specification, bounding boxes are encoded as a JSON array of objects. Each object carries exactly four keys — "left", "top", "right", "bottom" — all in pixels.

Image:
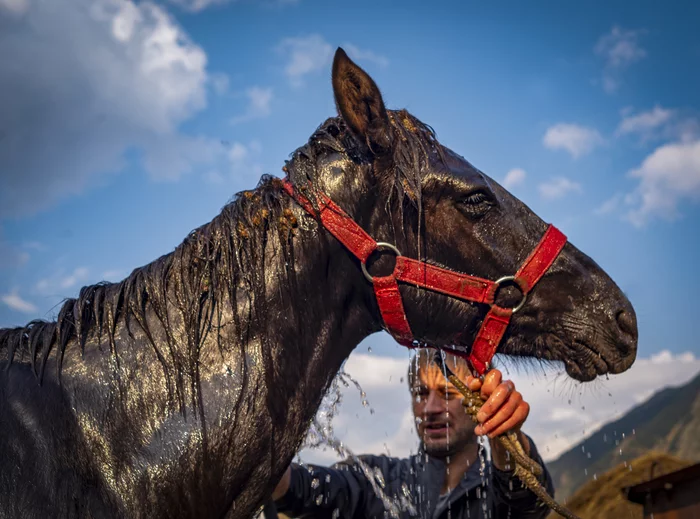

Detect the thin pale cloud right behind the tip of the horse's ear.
[{"left": 276, "top": 34, "right": 389, "bottom": 87}]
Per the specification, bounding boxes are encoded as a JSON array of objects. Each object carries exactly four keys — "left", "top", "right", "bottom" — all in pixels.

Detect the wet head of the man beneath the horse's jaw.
[{"left": 408, "top": 349, "right": 476, "bottom": 457}]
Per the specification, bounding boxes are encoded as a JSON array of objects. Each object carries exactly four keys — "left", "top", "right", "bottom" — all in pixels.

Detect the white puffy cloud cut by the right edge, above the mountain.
[{"left": 626, "top": 139, "right": 700, "bottom": 227}]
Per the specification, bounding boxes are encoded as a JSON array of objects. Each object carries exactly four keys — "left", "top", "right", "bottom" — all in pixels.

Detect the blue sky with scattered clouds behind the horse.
[{"left": 0, "top": 0, "right": 700, "bottom": 472}]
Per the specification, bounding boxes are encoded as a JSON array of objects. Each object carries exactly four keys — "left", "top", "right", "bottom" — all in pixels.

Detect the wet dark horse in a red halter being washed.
[{"left": 0, "top": 50, "right": 637, "bottom": 518}]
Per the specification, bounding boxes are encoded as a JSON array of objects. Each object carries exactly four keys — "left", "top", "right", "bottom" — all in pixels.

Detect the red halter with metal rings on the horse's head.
[{"left": 283, "top": 179, "right": 566, "bottom": 375}]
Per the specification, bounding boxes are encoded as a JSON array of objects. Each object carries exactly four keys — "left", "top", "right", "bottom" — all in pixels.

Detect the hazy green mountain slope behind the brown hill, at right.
[{"left": 547, "top": 374, "right": 700, "bottom": 500}]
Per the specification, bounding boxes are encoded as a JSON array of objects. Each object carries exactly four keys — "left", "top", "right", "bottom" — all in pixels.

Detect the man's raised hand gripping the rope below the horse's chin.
[{"left": 467, "top": 369, "right": 530, "bottom": 470}]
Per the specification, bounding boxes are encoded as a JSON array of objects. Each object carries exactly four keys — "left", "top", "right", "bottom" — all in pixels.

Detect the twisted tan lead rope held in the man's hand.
[{"left": 436, "top": 352, "right": 580, "bottom": 519}]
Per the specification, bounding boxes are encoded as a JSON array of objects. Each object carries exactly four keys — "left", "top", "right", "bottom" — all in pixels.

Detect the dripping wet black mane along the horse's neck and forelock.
[{"left": 0, "top": 110, "right": 441, "bottom": 404}]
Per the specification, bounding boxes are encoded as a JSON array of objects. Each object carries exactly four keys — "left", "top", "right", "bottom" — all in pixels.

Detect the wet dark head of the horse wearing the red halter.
[{"left": 286, "top": 49, "right": 637, "bottom": 381}]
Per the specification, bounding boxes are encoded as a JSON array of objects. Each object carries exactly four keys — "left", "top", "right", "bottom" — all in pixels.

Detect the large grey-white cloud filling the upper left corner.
[{"left": 0, "top": 0, "right": 221, "bottom": 218}]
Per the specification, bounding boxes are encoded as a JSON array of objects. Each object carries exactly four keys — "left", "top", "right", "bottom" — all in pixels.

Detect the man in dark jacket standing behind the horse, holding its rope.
[{"left": 272, "top": 349, "right": 553, "bottom": 519}]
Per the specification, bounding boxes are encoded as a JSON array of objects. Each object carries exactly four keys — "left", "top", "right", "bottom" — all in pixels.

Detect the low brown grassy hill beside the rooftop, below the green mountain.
[{"left": 549, "top": 452, "right": 691, "bottom": 519}]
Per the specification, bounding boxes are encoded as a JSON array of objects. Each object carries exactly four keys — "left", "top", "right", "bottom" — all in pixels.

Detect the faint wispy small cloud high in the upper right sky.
[{"left": 594, "top": 26, "right": 647, "bottom": 94}]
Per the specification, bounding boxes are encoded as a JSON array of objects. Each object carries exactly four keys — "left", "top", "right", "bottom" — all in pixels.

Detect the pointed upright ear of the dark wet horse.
[{"left": 333, "top": 47, "right": 392, "bottom": 155}]
